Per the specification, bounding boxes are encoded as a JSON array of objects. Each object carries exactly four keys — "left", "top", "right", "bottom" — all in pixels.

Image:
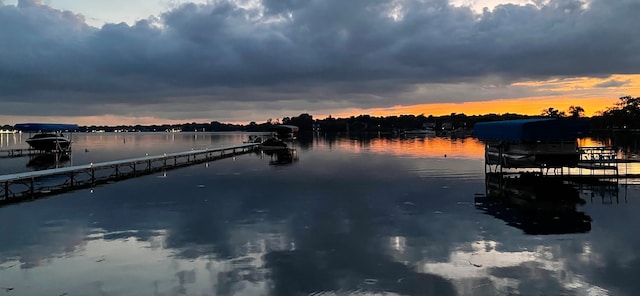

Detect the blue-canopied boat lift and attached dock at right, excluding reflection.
[{"left": 474, "top": 118, "right": 640, "bottom": 184}]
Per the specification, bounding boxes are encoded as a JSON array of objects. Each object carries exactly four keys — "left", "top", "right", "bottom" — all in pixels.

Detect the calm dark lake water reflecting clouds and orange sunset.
[{"left": 0, "top": 133, "right": 640, "bottom": 295}]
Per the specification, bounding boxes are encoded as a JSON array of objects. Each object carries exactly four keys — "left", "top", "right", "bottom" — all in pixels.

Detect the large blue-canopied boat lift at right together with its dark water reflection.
[{"left": 473, "top": 118, "right": 638, "bottom": 224}]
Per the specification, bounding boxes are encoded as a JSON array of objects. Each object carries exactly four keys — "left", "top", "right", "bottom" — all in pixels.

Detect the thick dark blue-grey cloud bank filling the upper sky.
[{"left": 0, "top": 0, "right": 640, "bottom": 118}]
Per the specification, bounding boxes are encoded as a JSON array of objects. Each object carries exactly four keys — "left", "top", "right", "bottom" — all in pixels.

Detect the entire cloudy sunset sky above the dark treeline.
[{"left": 0, "top": 0, "right": 640, "bottom": 125}]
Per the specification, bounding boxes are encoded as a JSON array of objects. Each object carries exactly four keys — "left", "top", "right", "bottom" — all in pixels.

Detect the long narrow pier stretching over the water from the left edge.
[{"left": 0, "top": 143, "right": 260, "bottom": 205}]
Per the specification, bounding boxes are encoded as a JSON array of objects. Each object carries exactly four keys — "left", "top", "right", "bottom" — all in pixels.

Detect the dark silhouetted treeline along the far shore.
[{"left": 0, "top": 96, "right": 640, "bottom": 134}]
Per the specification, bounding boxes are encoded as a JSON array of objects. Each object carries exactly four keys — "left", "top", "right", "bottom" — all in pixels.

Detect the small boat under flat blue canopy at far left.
[{"left": 14, "top": 123, "right": 78, "bottom": 152}]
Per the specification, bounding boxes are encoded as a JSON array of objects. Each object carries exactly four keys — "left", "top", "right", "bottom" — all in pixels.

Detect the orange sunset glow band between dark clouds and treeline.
[{"left": 3, "top": 75, "right": 640, "bottom": 126}]
